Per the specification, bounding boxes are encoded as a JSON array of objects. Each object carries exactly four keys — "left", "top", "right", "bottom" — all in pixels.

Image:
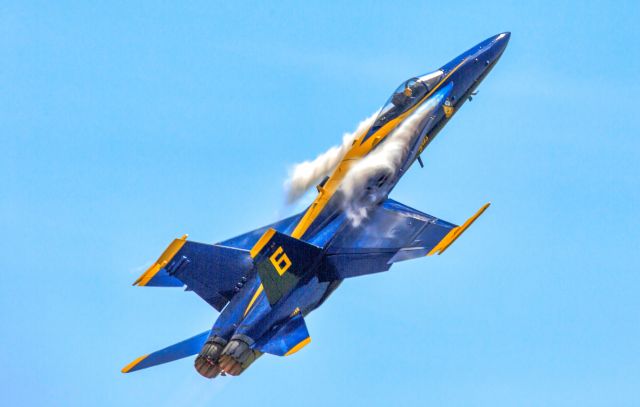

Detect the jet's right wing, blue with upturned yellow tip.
[{"left": 321, "top": 199, "right": 489, "bottom": 281}]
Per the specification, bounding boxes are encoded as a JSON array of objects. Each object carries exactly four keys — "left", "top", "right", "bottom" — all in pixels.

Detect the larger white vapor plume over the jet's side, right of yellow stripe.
[{"left": 340, "top": 98, "right": 440, "bottom": 227}]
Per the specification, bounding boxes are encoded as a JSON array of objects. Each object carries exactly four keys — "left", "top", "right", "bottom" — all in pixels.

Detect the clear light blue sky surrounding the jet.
[{"left": 0, "top": 1, "right": 640, "bottom": 406}]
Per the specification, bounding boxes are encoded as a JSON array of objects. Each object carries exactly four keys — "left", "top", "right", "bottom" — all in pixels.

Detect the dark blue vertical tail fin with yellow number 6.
[{"left": 250, "top": 229, "right": 322, "bottom": 305}]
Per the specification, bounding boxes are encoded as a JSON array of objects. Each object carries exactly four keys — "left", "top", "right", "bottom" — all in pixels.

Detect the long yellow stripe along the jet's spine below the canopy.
[{"left": 291, "top": 59, "right": 466, "bottom": 239}]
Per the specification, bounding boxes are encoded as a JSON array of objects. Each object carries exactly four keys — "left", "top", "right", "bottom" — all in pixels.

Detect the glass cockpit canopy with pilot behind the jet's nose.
[{"left": 365, "top": 70, "right": 444, "bottom": 135}]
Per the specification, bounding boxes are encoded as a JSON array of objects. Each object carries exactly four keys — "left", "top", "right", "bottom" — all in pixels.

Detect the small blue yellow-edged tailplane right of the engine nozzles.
[{"left": 256, "top": 311, "right": 311, "bottom": 356}]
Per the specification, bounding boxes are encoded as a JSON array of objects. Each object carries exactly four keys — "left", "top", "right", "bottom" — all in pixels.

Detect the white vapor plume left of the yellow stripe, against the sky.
[{"left": 284, "top": 112, "right": 378, "bottom": 203}]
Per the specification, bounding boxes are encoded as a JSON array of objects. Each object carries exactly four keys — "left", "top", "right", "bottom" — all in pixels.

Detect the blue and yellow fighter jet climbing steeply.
[{"left": 122, "top": 32, "right": 510, "bottom": 378}]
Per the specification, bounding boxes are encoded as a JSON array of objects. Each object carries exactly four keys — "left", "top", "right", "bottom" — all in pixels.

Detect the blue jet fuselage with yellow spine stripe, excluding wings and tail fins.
[{"left": 206, "top": 33, "right": 510, "bottom": 374}]
